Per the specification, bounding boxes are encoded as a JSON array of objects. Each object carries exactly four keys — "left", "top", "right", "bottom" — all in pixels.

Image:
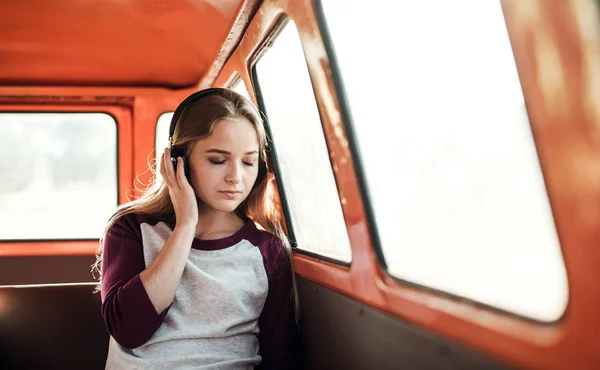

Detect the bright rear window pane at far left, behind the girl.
[{"left": 0, "top": 113, "right": 118, "bottom": 240}]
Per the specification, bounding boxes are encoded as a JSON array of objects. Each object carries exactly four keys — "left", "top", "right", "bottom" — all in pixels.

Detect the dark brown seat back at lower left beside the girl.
[{"left": 0, "top": 284, "right": 108, "bottom": 370}]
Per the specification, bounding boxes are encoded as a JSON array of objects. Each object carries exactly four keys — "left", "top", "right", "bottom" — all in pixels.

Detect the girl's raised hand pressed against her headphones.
[{"left": 160, "top": 148, "right": 198, "bottom": 230}]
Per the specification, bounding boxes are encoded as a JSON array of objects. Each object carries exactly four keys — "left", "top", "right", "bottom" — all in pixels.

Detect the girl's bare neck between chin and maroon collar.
[{"left": 195, "top": 207, "right": 244, "bottom": 240}]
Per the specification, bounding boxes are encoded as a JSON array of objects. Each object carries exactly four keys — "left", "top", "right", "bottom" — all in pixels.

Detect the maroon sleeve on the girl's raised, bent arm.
[{"left": 101, "top": 214, "right": 168, "bottom": 349}]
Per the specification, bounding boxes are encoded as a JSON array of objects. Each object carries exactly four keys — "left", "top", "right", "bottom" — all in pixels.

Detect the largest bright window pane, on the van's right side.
[{"left": 318, "top": 0, "right": 568, "bottom": 321}]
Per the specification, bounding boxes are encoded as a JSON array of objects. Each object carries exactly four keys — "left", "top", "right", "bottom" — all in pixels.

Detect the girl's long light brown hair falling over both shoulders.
[{"left": 92, "top": 89, "right": 299, "bottom": 318}]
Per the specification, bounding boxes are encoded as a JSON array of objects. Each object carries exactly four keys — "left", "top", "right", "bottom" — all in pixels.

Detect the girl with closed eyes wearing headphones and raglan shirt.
[{"left": 97, "top": 88, "right": 310, "bottom": 369}]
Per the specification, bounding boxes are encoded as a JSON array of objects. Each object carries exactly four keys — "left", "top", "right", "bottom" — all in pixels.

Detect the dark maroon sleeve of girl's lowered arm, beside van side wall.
[{"left": 257, "top": 238, "right": 305, "bottom": 370}]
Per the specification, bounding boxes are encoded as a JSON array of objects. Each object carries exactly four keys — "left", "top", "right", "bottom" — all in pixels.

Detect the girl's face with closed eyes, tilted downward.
[{"left": 189, "top": 118, "right": 259, "bottom": 212}]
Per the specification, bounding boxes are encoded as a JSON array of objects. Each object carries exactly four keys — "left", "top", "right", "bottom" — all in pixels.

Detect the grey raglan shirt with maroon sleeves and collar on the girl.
[{"left": 101, "top": 214, "right": 303, "bottom": 370}]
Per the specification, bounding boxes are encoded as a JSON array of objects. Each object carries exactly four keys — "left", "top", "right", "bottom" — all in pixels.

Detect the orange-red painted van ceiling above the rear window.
[{"left": 0, "top": 0, "right": 243, "bottom": 88}]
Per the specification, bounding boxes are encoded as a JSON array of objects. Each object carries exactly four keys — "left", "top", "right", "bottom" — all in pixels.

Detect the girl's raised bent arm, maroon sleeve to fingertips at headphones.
[{"left": 102, "top": 150, "right": 198, "bottom": 348}]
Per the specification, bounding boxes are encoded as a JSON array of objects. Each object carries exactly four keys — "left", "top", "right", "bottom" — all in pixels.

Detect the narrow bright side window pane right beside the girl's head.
[{"left": 256, "top": 21, "right": 352, "bottom": 262}]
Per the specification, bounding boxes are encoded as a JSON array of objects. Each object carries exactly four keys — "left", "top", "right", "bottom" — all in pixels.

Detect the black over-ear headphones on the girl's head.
[{"left": 169, "top": 87, "right": 267, "bottom": 190}]
